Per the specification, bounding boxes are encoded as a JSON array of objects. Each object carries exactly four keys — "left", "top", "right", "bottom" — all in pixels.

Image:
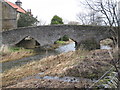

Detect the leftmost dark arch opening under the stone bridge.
[{"left": 15, "top": 36, "right": 40, "bottom": 49}]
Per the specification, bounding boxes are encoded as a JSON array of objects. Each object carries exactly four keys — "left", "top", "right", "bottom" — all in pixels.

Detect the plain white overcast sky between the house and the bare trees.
[{"left": 8, "top": 0, "right": 84, "bottom": 24}]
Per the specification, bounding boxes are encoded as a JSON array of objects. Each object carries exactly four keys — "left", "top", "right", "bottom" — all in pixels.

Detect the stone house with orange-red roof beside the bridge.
[{"left": 0, "top": 0, "right": 26, "bottom": 31}]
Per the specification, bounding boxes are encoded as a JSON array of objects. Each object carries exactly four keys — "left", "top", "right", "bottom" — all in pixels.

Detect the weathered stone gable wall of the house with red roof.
[{"left": 1, "top": 2, "right": 17, "bottom": 31}]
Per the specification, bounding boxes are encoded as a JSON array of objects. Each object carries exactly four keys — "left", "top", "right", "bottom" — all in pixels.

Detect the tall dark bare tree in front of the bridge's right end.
[{"left": 79, "top": 0, "right": 120, "bottom": 88}]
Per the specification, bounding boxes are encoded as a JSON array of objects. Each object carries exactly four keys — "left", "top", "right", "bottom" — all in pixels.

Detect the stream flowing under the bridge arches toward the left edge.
[{"left": 0, "top": 42, "right": 110, "bottom": 72}]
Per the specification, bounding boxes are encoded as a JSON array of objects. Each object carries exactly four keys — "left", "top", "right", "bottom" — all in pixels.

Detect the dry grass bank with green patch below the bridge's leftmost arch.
[{"left": 0, "top": 47, "right": 35, "bottom": 63}]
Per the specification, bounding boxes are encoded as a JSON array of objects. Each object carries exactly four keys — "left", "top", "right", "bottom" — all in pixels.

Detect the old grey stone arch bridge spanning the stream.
[{"left": 1, "top": 25, "right": 111, "bottom": 49}]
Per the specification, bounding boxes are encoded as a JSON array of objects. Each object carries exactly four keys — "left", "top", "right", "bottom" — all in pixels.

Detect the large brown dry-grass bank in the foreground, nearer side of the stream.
[{"left": 2, "top": 50, "right": 114, "bottom": 86}]
